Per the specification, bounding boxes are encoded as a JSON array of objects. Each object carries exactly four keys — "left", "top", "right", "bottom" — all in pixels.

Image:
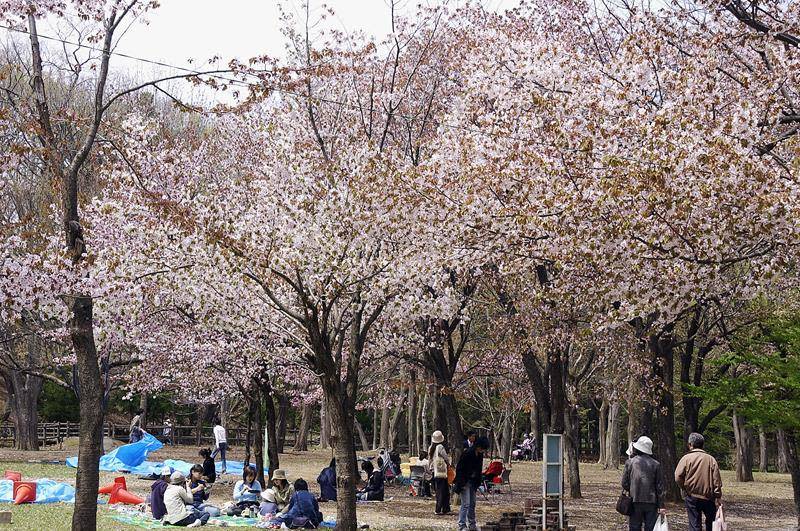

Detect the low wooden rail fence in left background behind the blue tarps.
[{"left": 0, "top": 422, "right": 304, "bottom": 447}]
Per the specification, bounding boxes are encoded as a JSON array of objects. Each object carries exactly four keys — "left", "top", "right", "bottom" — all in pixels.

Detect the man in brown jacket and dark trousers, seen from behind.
[{"left": 675, "top": 433, "right": 722, "bottom": 531}]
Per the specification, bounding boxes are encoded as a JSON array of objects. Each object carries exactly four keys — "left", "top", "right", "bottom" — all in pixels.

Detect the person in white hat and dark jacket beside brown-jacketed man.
[{"left": 622, "top": 435, "right": 666, "bottom": 531}]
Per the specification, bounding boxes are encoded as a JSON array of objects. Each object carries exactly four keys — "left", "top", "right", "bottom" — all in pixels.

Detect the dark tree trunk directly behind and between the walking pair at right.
[{"left": 643, "top": 332, "right": 681, "bottom": 502}]
